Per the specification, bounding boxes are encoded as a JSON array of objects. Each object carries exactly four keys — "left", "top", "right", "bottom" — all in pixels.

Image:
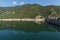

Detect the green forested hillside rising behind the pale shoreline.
[{"left": 0, "top": 4, "right": 60, "bottom": 18}]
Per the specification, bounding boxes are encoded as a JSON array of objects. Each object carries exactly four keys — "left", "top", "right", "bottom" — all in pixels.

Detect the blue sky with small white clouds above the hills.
[{"left": 0, "top": 0, "right": 60, "bottom": 7}]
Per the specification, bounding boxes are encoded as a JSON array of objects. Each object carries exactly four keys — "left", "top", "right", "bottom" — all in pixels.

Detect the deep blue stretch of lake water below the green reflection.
[{"left": 0, "top": 30, "right": 60, "bottom": 40}]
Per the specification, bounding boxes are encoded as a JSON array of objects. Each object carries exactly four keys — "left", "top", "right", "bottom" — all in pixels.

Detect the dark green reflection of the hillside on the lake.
[{"left": 0, "top": 21, "right": 56, "bottom": 32}]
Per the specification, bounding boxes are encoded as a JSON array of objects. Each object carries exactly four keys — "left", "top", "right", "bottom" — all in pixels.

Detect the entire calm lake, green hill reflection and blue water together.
[{"left": 0, "top": 21, "right": 60, "bottom": 40}]
